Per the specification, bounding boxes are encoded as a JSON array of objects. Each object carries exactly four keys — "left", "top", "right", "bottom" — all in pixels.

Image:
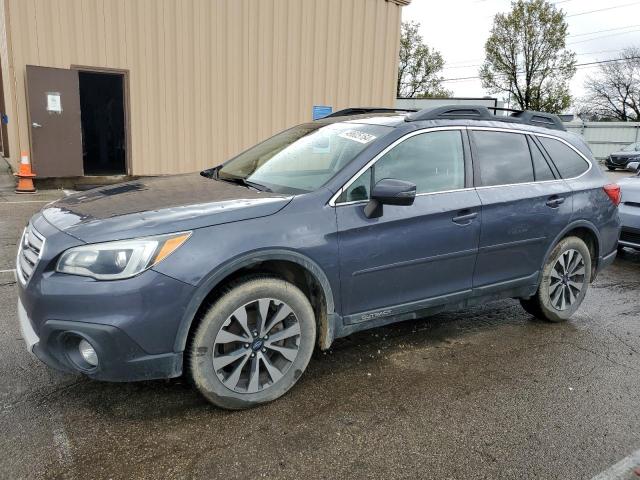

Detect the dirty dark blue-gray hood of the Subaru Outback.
[{"left": 42, "top": 173, "right": 292, "bottom": 242}]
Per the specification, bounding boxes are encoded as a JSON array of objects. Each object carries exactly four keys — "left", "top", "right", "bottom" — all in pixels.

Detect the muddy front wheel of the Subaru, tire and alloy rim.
[{"left": 187, "top": 277, "right": 316, "bottom": 410}]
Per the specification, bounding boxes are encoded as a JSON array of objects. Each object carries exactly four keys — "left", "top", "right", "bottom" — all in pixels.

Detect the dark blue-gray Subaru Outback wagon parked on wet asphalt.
[{"left": 17, "top": 106, "right": 620, "bottom": 408}]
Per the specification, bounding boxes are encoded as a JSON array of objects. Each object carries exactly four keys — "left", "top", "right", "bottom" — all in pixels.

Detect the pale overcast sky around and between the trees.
[{"left": 402, "top": 0, "right": 640, "bottom": 106}]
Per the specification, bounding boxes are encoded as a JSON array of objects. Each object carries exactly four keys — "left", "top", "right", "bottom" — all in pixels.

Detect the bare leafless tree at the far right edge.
[{"left": 579, "top": 47, "right": 640, "bottom": 122}]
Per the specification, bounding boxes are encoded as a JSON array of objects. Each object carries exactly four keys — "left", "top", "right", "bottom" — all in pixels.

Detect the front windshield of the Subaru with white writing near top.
[{"left": 217, "top": 123, "right": 393, "bottom": 194}]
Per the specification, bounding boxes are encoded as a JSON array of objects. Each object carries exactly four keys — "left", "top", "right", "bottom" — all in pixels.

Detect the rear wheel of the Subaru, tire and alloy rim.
[{"left": 520, "top": 237, "right": 591, "bottom": 322}]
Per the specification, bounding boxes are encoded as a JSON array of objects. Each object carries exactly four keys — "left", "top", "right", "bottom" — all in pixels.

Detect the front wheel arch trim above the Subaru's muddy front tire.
[{"left": 174, "top": 249, "right": 336, "bottom": 352}]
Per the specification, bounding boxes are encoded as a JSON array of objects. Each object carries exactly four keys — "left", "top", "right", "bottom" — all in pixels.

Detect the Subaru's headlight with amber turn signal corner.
[{"left": 56, "top": 232, "right": 191, "bottom": 280}]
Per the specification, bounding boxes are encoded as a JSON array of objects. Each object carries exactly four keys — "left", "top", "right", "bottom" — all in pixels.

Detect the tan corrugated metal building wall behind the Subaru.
[{"left": 0, "top": 0, "right": 407, "bottom": 175}]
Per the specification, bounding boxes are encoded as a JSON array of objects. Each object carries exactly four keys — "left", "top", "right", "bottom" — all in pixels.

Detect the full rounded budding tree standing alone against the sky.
[{"left": 480, "top": 0, "right": 576, "bottom": 113}]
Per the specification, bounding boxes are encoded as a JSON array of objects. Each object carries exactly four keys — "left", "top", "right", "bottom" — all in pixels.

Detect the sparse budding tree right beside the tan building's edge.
[{"left": 396, "top": 22, "right": 451, "bottom": 98}]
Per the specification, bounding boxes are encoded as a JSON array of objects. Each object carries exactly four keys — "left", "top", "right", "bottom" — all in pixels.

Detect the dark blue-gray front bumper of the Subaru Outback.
[{"left": 17, "top": 215, "right": 195, "bottom": 381}]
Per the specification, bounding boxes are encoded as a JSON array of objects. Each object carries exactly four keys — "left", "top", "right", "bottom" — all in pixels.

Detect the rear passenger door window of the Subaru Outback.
[{"left": 471, "top": 130, "right": 534, "bottom": 187}]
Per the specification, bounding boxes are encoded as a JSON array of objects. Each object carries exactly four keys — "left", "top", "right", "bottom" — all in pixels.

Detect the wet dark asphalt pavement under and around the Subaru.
[{"left": 0, "top": 170, "right": 640, "bottom": 479}]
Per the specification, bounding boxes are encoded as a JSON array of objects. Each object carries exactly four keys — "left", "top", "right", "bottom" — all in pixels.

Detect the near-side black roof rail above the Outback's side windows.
[{"left": 405, "top": 105, "right": 566, "bottom": 131}]
